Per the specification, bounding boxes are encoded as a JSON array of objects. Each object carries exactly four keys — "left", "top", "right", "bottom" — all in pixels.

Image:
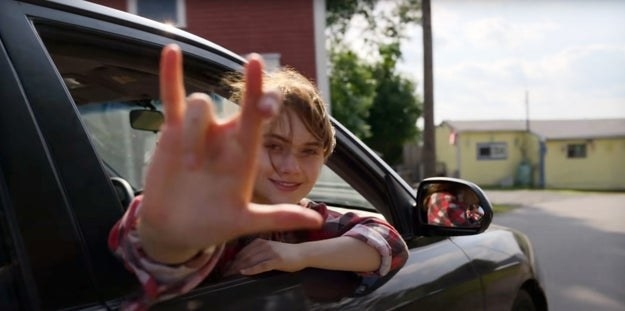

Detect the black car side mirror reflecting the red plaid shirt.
[{"left": 416, "top": 177, "right": 493, "bottom": 236}]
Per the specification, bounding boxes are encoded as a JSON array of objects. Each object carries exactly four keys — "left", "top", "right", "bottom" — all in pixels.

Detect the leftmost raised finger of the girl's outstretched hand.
[{"left": 160, "top": 44, "right": 185, "bottom": 125}]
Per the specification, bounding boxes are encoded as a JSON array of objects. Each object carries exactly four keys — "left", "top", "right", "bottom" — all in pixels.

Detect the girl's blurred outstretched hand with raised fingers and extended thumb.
[{"left": 138, "top": 45, "right": 322, "bottom": 263}]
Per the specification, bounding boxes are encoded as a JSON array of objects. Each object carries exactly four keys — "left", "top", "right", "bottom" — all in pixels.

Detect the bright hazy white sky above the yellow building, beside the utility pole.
[{"left": 392, "top": 0, "right": 625, "bottom": 124}]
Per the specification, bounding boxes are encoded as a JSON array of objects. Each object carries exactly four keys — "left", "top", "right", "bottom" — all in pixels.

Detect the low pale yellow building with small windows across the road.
[{"left": 436, "top": 119, "right": 625, "bottom": 190}]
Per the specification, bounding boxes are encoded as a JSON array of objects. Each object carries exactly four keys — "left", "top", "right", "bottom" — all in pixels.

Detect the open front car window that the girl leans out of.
[{"left": 35, "top": 23, "right": 381, "bottom": 222}]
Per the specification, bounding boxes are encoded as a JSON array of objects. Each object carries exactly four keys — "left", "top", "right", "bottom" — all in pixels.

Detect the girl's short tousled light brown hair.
[{"left": 225, "top": 67, "right": 336, "bottom": 159}]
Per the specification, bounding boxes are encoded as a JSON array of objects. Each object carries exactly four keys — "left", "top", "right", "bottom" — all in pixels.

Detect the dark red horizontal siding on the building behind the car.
[{"left": 93, "top": 0, "right": 317, "bottom": 81}]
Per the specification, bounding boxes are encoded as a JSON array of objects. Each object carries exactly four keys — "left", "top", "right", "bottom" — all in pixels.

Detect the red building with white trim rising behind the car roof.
[{"left": 92, "top": 0, "right": 330, "bottom": 103}]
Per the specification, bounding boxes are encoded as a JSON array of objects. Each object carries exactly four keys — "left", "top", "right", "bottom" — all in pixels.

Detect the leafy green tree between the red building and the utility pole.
[{"left": 326, "top": 0, "right": 422, "bottom": 164}]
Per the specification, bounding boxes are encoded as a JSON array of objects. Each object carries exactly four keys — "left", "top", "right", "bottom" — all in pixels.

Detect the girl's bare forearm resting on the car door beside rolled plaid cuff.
[{"left": 299, "top": 236, "right": 381, "bottom": 272}]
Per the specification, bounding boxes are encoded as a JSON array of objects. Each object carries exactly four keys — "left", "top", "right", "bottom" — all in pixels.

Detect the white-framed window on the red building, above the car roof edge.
[{"left": 128, "top": 0, "right": 187, "bottom": 28}]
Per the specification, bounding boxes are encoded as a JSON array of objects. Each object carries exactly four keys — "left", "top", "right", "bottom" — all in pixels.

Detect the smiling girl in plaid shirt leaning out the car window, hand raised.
[{"left": 109, "top": 45, "right": 408, "bottom": 309}]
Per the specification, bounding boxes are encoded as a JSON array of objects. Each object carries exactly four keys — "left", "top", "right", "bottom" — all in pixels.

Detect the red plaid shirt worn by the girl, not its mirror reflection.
[{"left": 108, "top": 196, "right": 408, "bottom": 310}]
